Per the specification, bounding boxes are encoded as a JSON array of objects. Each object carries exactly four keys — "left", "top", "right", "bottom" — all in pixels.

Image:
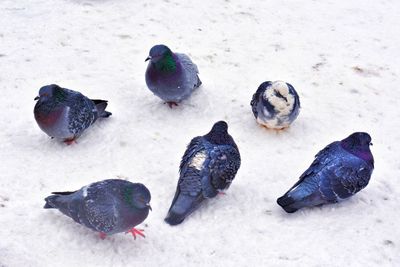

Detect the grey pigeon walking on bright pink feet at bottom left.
[{"left": 44, "top": 179, "right": 151, "bottom": 239}]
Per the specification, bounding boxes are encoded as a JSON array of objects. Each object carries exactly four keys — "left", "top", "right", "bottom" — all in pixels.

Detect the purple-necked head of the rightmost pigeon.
[{"left": 340, "top": 132, "right": 374, "bottom": 166}]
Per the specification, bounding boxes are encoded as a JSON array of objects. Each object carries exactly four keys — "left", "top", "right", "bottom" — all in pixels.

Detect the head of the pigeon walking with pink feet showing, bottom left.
[{"left": 124, "top": 183, "right": 151, "bottom": 210}]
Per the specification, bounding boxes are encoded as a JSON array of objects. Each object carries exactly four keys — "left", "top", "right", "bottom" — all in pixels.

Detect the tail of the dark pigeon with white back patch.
[{"left": 164, "top": 194, "right": 204, "bottom": 225}]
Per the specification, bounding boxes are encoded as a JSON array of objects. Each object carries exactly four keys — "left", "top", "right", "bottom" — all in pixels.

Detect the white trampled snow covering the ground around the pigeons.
[{"left": 0, "top": 0, "right": 400, "bottom": 266}]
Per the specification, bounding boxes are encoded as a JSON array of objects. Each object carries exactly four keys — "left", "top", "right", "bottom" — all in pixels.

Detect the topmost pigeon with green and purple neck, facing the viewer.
[{"left": 145, "top": 45, "right": 201, "bottom": 108}]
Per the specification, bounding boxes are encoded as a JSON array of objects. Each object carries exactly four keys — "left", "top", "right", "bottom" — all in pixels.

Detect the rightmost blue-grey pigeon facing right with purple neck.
[{"left": 277, "top": 132, "right": 374, "bottom": 213}]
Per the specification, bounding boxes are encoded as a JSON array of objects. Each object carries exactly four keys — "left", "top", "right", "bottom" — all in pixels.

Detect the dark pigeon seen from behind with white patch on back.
[{"left": 165, "top": 121, "right": 240, "bottom": 225}]
